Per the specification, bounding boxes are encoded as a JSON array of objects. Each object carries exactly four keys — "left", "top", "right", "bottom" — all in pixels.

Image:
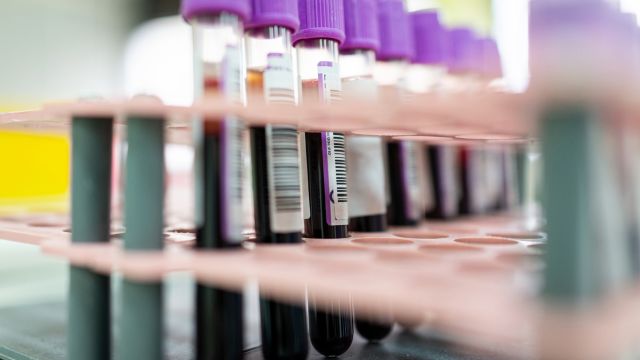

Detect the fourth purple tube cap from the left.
[{"left": 340, "top": 0, "right": 380, "bottom": 51}]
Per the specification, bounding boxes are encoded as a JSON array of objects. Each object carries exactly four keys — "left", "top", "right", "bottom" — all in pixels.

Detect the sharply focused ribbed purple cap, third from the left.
[{"left": 293, "top": 0, "right": 345, "bottom": 45}]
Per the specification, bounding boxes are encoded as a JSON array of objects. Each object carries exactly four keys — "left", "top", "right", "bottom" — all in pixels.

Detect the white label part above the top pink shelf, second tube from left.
[{"left": 264, "top": 53, "right": 296, "bottom": 104}]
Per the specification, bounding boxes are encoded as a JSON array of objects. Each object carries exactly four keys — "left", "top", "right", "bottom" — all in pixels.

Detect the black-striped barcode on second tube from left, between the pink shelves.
[{"left": 271, "top": 126, "right": 301, "bottom": 213}]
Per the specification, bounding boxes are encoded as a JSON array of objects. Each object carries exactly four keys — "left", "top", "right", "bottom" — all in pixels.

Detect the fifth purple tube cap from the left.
[{"left": 377, "top": 0, "right": 413, "bottom": 61}]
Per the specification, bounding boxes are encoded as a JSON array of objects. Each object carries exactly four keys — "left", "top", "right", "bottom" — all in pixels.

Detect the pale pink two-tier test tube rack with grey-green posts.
[{"left": 0, "top": 88, "right": 640, "bottom": 359}]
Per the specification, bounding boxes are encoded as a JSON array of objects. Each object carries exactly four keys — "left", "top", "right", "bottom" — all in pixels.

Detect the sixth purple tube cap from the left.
[{"left": 410, "top": 11, "right": 447, "bottom": 65}]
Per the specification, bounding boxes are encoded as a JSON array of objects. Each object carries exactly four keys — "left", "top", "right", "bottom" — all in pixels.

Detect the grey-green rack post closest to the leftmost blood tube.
[{"left": 116, "top": 117, "right": 165, "bottom": 360}]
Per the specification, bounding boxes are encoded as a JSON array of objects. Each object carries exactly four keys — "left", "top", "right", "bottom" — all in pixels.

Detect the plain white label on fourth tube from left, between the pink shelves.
[{"left": 347, "top": 136, "right": 386, "bottom": 218}]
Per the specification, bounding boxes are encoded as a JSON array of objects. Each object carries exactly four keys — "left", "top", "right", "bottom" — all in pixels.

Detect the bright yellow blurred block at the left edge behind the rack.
[{"left": 0, "top": 131, "right": 70, "bottom": 213}]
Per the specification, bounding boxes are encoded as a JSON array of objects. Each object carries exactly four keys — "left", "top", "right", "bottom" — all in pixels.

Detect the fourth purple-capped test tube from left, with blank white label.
[{"left": 340, "top": 0, "right": 393, "bottom": 341}]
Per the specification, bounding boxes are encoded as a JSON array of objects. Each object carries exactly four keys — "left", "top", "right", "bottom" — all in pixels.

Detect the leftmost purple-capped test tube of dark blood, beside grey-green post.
[{"left": 182, "top": 0, "right": 251, "bottom": 359}]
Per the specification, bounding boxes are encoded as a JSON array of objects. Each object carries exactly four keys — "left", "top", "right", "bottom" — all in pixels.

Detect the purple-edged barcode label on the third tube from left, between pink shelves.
[{"left": 322, "top": 132, "right": 349, "bottom": 225}]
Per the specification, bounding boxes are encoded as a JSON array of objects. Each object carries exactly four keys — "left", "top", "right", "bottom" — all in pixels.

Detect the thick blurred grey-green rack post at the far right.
[{"left": 540, "top": 104, "right": 601, "bottom": 302}]
